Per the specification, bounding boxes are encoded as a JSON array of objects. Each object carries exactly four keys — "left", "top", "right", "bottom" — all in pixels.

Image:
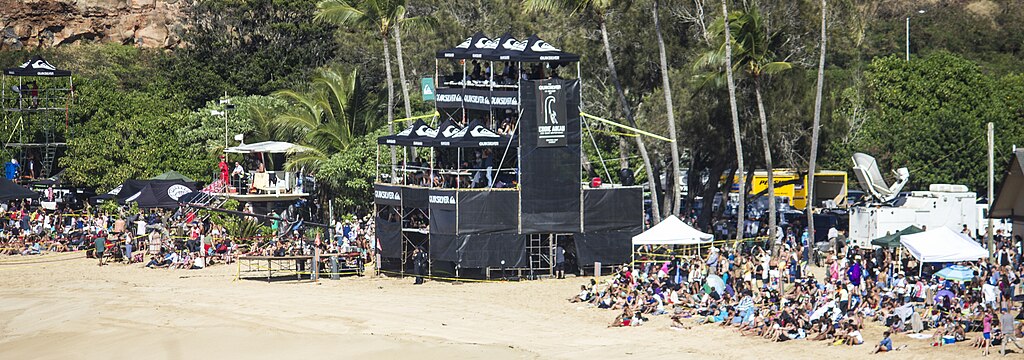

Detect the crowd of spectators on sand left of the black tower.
[{"left": 0, "top": 198, "right": 375, "bottom": 269}]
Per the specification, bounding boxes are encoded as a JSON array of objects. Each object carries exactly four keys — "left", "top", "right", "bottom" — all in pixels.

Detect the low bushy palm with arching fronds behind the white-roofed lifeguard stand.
[{"left": 273, "top": 69, "right": 376, "bottom": 171}]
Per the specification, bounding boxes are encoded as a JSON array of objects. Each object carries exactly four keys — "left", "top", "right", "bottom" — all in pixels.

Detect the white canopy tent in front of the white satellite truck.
[{"left": 900, "top": 226, "right": 988, "bottom": 263}]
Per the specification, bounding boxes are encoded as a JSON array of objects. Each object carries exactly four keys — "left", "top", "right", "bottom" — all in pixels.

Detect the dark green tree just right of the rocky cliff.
[{"left": 174, "top": 0, "right": 339, "bottom": 108}]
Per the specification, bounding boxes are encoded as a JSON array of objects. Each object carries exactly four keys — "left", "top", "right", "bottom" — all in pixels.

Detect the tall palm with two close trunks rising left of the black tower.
[{"left": 315, "top": 0, "right": 412, "bottom": 179}]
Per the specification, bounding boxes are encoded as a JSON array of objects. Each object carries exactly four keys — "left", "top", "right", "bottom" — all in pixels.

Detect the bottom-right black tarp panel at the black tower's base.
[{"left": 573, "top": 227, "right": 641, "bottom": 266}]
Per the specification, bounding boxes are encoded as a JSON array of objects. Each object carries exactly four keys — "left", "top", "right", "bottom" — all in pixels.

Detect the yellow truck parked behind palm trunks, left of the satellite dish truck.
[{"left": 733, "top": 169, "right": 849, "bottom": 210}]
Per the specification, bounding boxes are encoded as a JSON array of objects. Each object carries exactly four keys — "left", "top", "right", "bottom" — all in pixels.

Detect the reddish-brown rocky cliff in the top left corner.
[{"left": 0, "top": 0, "right": 194, "bottom": 50}]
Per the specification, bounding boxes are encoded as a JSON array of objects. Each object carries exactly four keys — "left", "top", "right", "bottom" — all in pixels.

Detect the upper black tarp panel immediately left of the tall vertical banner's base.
[{"left": 458, "top": 191, "right": 519, "bottom": 234}]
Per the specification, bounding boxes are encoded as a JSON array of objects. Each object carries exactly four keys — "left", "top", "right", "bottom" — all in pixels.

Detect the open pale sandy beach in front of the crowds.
[{"left": 0, "top": 253, "right": 999, "bottom": 359}]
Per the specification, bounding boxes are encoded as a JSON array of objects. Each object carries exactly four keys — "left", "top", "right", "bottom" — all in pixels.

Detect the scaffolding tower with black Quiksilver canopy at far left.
[{"left": 0, "top": 56, "right": 74, "bottom": 179}]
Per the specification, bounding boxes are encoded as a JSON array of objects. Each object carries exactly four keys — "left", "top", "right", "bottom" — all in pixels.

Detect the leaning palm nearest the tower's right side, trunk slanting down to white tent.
[{"left": 523, "top": 0, "right": 662, "bottom": 224}]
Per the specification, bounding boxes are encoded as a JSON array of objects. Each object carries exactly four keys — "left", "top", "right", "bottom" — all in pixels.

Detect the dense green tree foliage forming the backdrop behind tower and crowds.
[{"left": 0, "top": 0, "right": 1024, "bottom": 217}]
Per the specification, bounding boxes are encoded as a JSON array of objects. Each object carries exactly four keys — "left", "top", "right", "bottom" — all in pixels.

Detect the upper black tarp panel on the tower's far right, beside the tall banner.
[{"left": 583, "top": 187, "right": 643, "bottom": 232}]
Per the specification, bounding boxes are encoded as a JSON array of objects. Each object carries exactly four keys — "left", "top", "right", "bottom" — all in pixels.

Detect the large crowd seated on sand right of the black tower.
[{"left": 570, "top": 228, "right": 1024, "bottom": 355}]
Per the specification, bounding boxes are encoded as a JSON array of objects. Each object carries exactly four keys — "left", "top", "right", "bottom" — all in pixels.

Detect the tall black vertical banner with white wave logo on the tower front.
[{"left": 519, "top": 79, "right": 583, "bottom": 233}]
